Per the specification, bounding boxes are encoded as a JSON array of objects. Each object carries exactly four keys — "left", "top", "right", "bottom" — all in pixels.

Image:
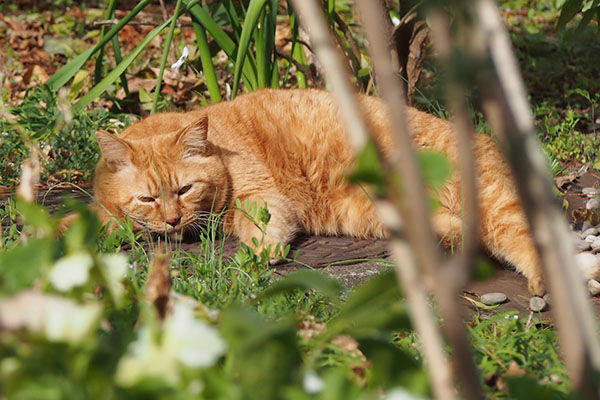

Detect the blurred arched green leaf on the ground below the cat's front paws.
[{"left": 258, "top": 269, "right": 341, "bottom": 300}]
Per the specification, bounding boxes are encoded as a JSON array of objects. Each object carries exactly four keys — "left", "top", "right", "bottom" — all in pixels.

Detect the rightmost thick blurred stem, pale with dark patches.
[{"left": 470, "top": 0, "right": 600, "bottom": 399}]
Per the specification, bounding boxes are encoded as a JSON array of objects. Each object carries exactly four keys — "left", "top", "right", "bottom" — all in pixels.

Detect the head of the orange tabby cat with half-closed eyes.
[{"left": 94, "top": 115, "right": 229, "bottom": 234}]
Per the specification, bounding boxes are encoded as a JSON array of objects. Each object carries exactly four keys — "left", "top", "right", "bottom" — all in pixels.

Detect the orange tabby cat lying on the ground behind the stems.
[{"left": 94, "top": 90, "right": 544, "bottom": 294}]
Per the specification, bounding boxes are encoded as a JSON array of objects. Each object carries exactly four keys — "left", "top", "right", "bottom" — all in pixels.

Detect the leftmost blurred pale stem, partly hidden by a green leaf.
[{"left": 293, "top": 0, "right": 456, "bottom": 399}]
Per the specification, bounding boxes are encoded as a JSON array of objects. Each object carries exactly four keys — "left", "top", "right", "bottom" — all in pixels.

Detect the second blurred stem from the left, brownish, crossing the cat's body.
[{"left": 358, "top": 0, "right": 483, "bottom": 399}]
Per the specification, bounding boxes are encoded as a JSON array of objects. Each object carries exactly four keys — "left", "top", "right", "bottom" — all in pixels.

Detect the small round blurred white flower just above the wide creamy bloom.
[{"left": 49, "top": 252, "right": 94, "bottom": 292}]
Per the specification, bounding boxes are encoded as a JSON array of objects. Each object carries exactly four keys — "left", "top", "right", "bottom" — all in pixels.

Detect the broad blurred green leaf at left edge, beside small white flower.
[{"left": 0, "top": 238, "right": 58, "bottom": 295}]
